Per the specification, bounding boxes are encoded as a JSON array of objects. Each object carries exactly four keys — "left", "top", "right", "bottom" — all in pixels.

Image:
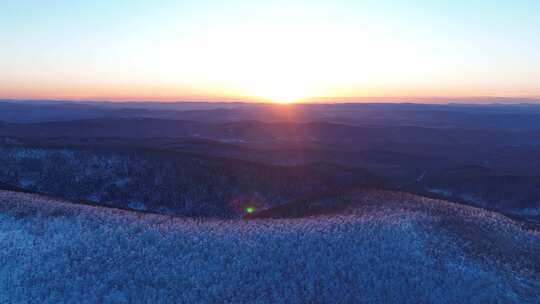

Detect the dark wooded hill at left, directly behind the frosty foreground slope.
[{"left": 0, "top": 146, "right": 385, "bottom": 218}]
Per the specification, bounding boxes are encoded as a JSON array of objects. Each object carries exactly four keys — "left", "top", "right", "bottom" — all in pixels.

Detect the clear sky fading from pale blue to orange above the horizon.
[{"left": 0, "top": 0, "right": 540, "bottom": 102}]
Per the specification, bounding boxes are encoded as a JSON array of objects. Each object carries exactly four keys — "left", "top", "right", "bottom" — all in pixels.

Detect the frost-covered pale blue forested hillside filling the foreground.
[{"left": 0, "top": 191, "right": 540, "bottom": 303}]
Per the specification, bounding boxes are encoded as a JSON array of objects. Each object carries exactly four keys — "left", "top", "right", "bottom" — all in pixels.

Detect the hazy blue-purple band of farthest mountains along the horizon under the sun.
[{"left": 0, "top": 100, "right": 540, "bottom": 131}]
